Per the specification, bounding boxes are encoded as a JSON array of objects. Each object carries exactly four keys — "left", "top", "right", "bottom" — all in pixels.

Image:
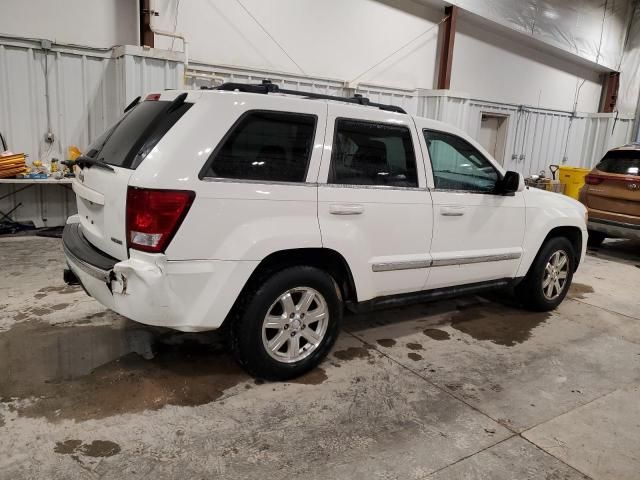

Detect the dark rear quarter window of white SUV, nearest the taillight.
[{"left": 203, "top": 112, "right": 316, "bottom": 182}]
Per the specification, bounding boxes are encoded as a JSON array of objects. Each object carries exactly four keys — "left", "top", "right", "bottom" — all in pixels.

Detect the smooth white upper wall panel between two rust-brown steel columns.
[{"left": 153, "top": 0, "right": 444, "bottom": 89}]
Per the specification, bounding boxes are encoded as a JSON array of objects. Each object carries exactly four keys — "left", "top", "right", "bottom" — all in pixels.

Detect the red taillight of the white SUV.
[{"left": 127, "top": 187, "right": 195, "bottom": 253}]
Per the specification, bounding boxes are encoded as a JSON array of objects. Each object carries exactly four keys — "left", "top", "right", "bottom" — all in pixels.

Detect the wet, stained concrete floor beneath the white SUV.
[{"left": 0, "top": 237, "right": 640, "bottom": 480}]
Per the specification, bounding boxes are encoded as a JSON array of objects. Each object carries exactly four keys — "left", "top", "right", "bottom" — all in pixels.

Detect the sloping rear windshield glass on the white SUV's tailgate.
[{"left": 87, "top": 101, "right": 192, "bottom": 169}]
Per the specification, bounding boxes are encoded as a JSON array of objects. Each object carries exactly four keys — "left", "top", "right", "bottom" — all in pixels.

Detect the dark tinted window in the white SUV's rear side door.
[{"left": 329, "top": 119, "right": 418, "bottom": 187}]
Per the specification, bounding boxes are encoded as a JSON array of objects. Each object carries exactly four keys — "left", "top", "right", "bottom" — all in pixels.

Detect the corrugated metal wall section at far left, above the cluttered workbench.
[{"left": 0, "top": 41, "right": 118, "bottom": 165}]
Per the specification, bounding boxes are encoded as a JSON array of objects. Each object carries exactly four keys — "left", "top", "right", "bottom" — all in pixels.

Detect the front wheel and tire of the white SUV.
[{"left": 515, "top": 237, "right": 576, "bottom": 312}]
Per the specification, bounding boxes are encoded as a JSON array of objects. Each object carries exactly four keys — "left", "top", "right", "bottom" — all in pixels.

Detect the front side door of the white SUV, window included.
[{"left": 422, "top": 129, "right": 525, "bottom": 289}]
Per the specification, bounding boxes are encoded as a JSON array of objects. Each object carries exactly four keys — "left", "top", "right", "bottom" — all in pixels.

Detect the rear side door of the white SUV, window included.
[{"left": 318, "top": 105, "right": 433, "bottom": 301}]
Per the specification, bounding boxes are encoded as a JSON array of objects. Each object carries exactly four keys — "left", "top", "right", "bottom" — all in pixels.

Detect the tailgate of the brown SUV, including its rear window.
[{"left": 582, "top": 149, "right": 640, "bottom": 224}]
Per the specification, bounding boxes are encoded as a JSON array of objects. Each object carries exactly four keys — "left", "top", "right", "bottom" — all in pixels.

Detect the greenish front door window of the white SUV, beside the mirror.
[{"left": 424, "top": 130, "right": 499, "bottom": 193}]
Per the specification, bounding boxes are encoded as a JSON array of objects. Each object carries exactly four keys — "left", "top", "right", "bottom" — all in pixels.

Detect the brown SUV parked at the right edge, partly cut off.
[{"left": 580, "top": 143, "right": 640, "bottom": 246}]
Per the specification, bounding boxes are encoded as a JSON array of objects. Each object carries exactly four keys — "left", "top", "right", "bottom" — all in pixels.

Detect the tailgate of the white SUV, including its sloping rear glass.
[{"left": 73, "top": 92, "right": 193, "bottom": 259}]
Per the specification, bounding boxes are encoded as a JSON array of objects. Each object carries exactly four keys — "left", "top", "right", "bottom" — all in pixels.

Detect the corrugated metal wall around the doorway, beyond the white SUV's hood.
[{"left": 418, "top": 90, "right": 633, "bottom": 175}]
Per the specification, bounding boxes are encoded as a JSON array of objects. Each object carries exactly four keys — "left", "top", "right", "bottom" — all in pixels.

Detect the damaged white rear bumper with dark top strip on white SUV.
[{"left": 63, "top": 224, "right": 258, "bottom": 332}]
